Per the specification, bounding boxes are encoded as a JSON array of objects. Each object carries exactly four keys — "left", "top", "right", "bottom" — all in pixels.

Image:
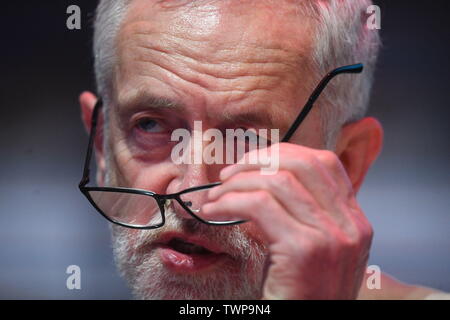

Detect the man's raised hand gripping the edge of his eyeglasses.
[{"left": 202, "top": 143, "right": 373, "bottom": 299}]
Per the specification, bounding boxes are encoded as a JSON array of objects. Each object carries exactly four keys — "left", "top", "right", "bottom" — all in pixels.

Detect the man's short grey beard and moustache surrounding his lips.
[{"left": 112, "top": 210, "right": 268, "bottom": 300}]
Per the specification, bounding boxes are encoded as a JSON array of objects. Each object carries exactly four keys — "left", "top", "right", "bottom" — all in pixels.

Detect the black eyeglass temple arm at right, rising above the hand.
[{"left": 281, "top": 63, "right": 364, "bottom": 142}]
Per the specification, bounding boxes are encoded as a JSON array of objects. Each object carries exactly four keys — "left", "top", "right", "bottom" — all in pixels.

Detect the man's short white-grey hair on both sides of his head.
[{"left": 94, "top": 0, "right": 380, "bottom": 149}]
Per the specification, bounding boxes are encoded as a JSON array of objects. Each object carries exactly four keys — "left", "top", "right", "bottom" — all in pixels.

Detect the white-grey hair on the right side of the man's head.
[{"left": 304, "top": 0, "right": 381, "bottom": 149}]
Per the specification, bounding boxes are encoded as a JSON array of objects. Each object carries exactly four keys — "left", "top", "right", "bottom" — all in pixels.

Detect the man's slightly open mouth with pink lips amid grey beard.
[{"left": 159, "top": 236, "right": 226, "bottom": 273}]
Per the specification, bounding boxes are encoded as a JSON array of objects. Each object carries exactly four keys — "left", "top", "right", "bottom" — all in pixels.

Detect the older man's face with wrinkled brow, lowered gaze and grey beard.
[{"left": 105, "top": 0, "right": 324, "bottom": 298}]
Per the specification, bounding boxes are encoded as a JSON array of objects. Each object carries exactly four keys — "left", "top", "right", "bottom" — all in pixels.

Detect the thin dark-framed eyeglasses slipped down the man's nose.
[{"left": 78, "top": 64, "right": 363, "bottom": 229}]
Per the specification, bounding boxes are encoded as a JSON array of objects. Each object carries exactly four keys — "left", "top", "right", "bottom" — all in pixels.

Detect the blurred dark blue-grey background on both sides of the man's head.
[{"left": 0, "top": 0, "right": 450, "bottom": 299}]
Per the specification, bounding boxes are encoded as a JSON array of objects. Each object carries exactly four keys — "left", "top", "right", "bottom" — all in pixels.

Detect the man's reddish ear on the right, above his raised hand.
[{"left": 335, "top": 117, "right": 383, "bottom": 192}]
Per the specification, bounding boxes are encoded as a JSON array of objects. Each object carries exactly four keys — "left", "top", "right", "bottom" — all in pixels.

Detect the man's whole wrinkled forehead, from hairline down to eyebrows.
[{"left": 115, "top": 0, "right": 312, "bottom": 129}]
